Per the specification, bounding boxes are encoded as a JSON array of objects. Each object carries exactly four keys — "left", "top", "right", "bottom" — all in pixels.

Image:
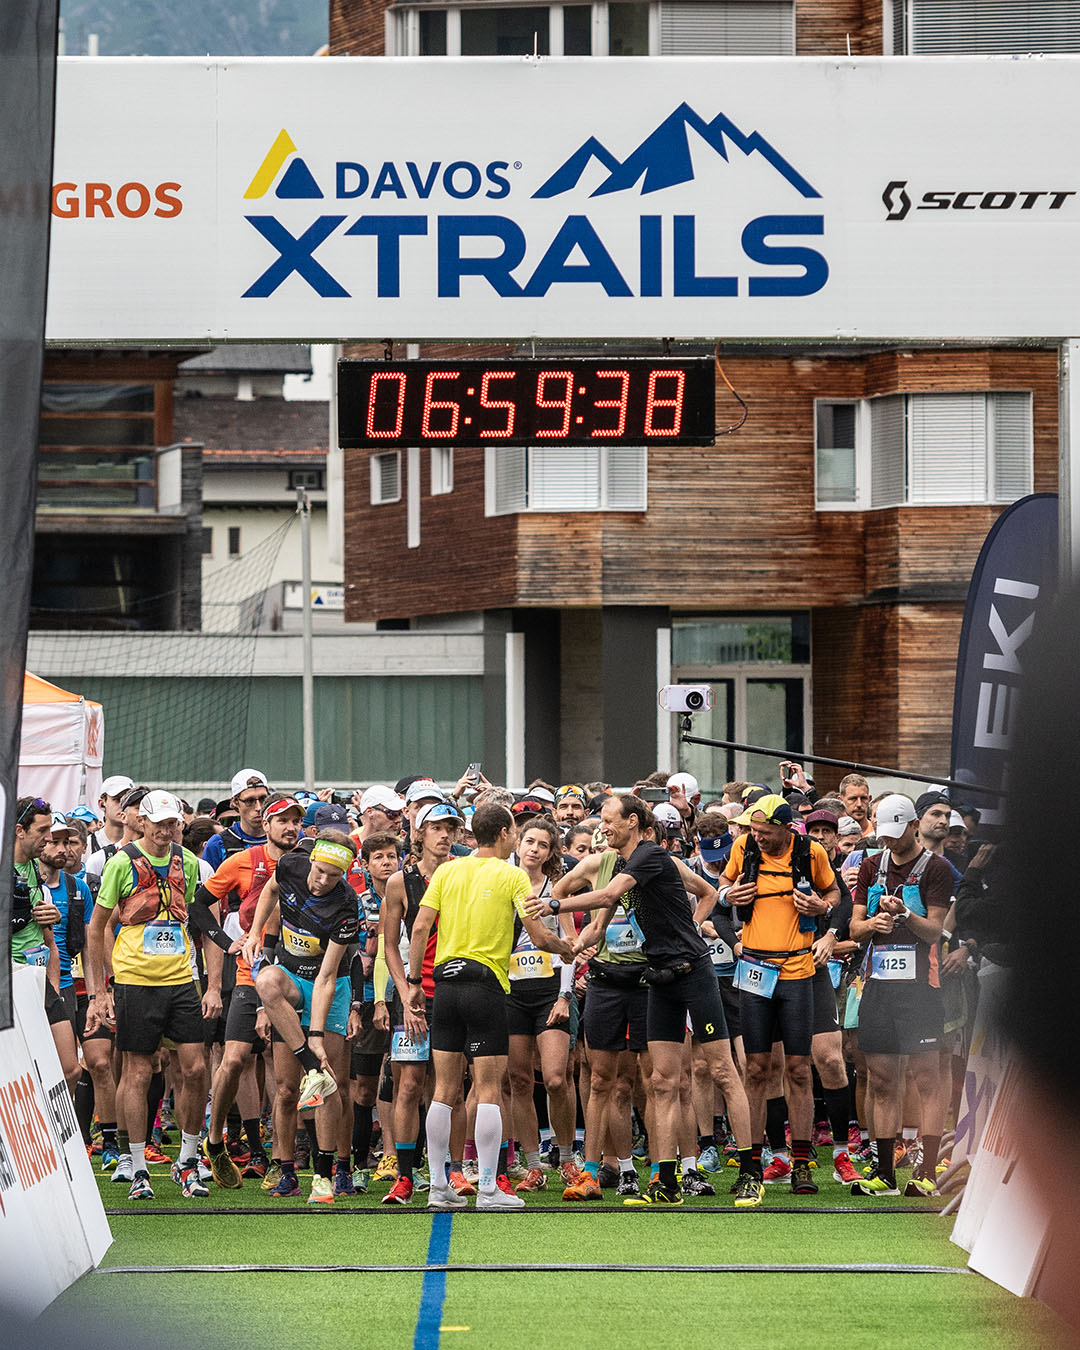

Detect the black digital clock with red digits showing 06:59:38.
[{"left": 338, "top": 356, "right": 716, "bottom": 450}]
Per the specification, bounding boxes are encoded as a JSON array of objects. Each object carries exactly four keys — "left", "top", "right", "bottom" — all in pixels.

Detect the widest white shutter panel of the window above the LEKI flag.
[{"left": 907, "top": 394, "right": 987, "bottom": 505}]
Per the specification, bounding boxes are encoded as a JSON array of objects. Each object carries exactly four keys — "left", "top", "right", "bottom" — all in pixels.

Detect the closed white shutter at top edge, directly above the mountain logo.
[{"left": 660, "top": 0, "right": 795, "bottom": 57}]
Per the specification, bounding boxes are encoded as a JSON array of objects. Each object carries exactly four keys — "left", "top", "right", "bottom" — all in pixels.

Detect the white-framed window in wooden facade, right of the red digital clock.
[{"left": 814, "top": 393, "right": 1033, "bottom": 510}]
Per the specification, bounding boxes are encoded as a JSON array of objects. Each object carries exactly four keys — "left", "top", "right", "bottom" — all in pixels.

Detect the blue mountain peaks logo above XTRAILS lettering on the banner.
[{"left": 533, "top": 103, "right": 821, "bottom": 197}]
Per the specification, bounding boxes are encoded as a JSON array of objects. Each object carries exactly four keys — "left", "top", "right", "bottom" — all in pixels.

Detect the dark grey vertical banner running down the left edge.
[{"left": 0, "top": 0, "right": 59, "bottom": 1027}]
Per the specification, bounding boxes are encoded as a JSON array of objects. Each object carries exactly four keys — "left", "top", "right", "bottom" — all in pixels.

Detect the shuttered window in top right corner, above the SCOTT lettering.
[{"left": 887, "top": 0, "right": 1080, "bottom": 55}]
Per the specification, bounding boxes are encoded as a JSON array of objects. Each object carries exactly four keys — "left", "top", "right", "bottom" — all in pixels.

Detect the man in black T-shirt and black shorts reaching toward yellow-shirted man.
[{"left": 527, "top": 795, "right": 764, "bottom": 1208}]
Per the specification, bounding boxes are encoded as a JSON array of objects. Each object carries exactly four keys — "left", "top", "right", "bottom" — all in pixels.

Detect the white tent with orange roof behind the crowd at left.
[{"left": 19, "top": 671, "right": 105, "bottom": 811}]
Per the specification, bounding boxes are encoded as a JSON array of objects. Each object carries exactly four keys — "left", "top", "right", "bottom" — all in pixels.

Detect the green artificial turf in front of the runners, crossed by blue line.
[{"left": 43, "top": 1150, "right": 1060, "bottom": 1350}]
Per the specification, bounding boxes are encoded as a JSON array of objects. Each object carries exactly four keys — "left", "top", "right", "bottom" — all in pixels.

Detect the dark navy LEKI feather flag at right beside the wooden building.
[{"left": 952, "top": 493, "right": 1058, "bottom": 830}]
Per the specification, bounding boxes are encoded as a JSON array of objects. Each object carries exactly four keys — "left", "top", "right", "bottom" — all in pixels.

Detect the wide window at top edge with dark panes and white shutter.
[{"left": 386, "top": 0, "right": 793, "bottom": 57}]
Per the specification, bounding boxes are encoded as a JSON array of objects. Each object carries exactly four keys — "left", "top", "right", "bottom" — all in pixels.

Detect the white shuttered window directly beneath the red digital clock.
[{"left": 485, "top": 446, "right": 648, "bottom": 516}]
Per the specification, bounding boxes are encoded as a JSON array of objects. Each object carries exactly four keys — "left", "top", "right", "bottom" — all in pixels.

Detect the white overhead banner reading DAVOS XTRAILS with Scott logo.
[{"left": 49, "top": 57, "right": 1080, "bottom": 342}]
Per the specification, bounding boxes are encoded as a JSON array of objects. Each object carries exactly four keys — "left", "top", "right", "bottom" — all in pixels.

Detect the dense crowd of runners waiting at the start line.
[{"left": 12, "top": 761, "right": 994, "bottom": 1210}]
